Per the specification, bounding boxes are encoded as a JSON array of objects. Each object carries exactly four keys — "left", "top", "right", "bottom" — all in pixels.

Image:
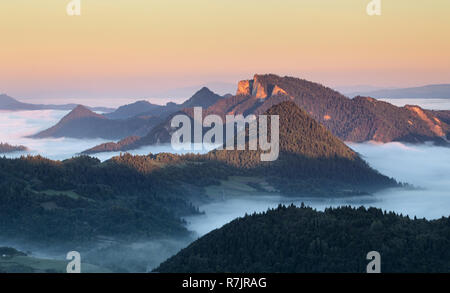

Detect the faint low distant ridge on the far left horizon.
[{"left": 0, "top": 94, "right": 114, "bottom": 112}]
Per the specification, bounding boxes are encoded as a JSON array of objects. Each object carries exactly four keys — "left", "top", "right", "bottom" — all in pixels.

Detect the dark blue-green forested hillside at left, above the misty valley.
[{"left": 0, "top": 156, "right": 202, "bottom": 243}]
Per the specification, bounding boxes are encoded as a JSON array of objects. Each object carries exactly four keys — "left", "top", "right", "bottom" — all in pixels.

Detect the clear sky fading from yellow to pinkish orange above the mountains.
[{"left": 0, "top": 0, "right": 450, "bottom": 104}]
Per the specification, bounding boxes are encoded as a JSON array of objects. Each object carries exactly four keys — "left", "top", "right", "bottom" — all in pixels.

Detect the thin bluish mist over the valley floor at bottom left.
[{"left": 0, "top": 235, "right": 196, "bottom": 273}]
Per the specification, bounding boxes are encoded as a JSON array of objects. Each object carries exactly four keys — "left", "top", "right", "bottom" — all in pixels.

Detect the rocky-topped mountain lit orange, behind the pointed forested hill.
[{"left": 90, "top": 74, "right": 450, "bottom": 151}]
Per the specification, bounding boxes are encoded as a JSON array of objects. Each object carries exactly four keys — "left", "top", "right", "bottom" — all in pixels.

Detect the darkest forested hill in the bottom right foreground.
[{"left": 155, "top": 206, "right": 450, "bottom": 273}]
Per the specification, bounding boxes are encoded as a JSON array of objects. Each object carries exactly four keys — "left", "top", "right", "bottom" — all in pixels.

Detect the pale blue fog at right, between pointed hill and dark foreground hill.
[{"left": 186, "top": 143, "right": 450, "bottom": 236}]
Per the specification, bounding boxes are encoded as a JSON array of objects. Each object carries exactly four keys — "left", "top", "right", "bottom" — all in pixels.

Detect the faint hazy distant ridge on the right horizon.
[{"left": 346, "top": 84, "right": 450, "bottom": 99}]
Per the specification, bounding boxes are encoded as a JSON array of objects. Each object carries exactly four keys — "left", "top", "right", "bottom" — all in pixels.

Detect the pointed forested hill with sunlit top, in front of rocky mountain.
[{"left": 205, "top": 102, "right": 396, "bottom": 195}]
